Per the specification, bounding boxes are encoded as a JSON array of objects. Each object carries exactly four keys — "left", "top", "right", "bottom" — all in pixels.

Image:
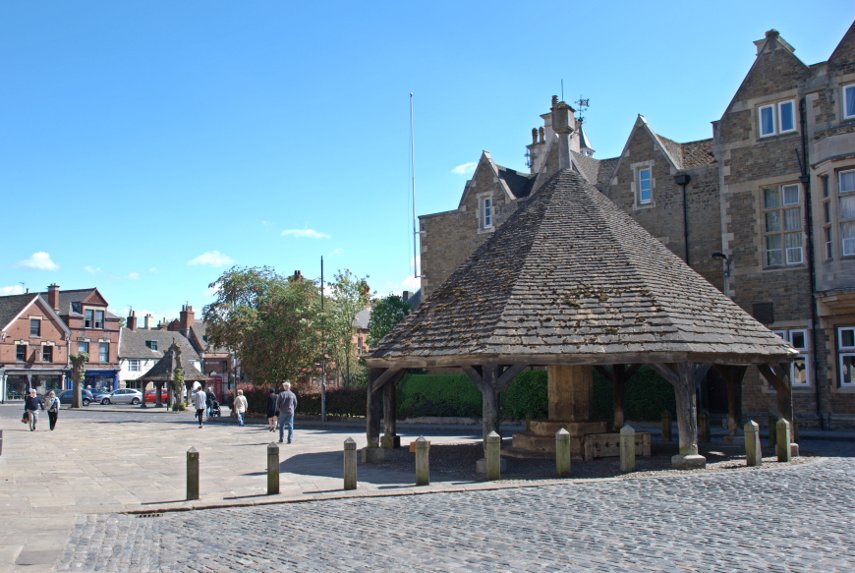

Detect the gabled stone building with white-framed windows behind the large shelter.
[{"left": 420, "top": 24, "right": 855, "bottom": 427}]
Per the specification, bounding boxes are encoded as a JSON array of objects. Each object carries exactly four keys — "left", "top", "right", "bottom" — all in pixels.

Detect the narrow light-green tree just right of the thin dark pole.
[{"left": 323, "top": 269, "right": 371, "bottom": 387}]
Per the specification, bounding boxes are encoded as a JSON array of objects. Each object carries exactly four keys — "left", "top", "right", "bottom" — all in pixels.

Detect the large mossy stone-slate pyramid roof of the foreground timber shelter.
[{"left": 366, "top": 169, "right": 795, "bottom": 367}]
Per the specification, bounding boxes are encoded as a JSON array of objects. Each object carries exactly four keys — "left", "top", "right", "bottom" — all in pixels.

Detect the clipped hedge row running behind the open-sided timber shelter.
[{"left": 288, "top": 368, "right": 676, "bottom": 421}]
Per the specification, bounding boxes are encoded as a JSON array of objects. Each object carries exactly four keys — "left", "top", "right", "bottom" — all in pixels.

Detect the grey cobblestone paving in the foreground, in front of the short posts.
[{"left": 57, "top": 454, "right": 855, "bottom": 573}]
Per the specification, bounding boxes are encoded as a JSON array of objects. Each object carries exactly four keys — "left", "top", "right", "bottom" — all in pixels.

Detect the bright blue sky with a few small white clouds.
[{"left": 0, "top": 0, "right": 855, "bottom": 318}]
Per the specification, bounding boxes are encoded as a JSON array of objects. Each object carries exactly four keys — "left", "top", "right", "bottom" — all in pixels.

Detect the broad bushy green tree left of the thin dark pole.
[{"left": 203, "top": 267, "right": 321, "bottom": 384}]
